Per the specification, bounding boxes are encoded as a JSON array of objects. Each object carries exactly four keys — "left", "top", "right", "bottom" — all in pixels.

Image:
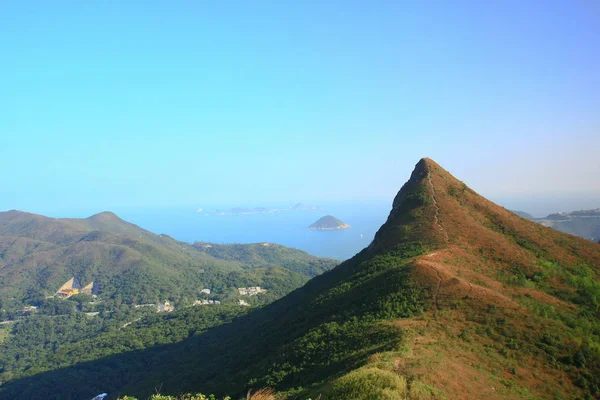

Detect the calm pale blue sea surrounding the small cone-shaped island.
[{"left": 115, "top": 203, "right": 390, "bottom": 260}]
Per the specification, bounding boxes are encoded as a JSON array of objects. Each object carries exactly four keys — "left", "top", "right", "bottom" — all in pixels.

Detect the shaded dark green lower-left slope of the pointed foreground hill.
[{"left": 3, "top": 244, "right": 427, "bottom": 398}]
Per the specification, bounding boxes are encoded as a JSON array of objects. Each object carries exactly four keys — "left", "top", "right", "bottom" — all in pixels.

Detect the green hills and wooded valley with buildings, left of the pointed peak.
[{"left": 0, "top": 212, "right": 337, "bottom": 394}]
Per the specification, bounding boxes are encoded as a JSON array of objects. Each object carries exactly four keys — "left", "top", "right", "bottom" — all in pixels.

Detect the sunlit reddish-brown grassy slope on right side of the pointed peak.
[{"left": 328, "top": 160, "right": 600, "bottom": 398}]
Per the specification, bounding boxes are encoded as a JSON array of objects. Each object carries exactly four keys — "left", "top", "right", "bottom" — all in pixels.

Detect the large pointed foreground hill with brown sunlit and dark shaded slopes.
[{"left": 0, "top": 159, "right": 600, "bottom": 400}]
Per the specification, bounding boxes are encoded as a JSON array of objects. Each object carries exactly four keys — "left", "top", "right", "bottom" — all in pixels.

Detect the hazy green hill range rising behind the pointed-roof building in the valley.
[{"left": 0, "top": 211, "right": 337, "bottom": 311}]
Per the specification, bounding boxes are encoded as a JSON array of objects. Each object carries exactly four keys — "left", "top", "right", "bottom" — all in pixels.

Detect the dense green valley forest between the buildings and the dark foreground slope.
[{"left": 0, "top": 305, "right": 247, "bottom": 381}]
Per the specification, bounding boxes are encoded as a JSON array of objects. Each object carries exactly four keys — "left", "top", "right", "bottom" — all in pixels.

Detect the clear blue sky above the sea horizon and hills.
[{"left": 0, "top": 0, "right": 600, "bottom": 216}]
